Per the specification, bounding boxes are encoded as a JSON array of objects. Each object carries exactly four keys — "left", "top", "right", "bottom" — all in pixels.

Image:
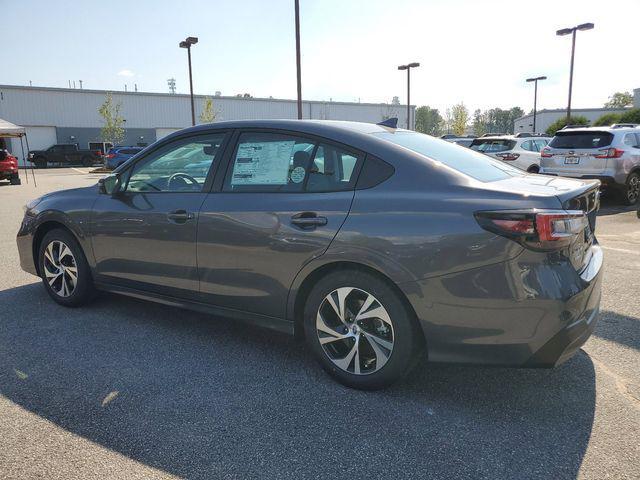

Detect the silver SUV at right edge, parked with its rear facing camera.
[{"left": 540, "top": 124, "right": 640, "bottom": 205}]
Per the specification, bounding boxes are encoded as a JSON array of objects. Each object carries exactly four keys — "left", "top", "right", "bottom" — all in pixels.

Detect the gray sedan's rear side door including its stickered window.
[{"left": 197, "top": 131, "right": 362, "bottom": 318}]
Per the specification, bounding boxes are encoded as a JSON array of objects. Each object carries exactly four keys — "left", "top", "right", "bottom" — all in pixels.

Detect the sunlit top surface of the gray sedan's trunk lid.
[{"left": 484, "top": 174, "right": 600, "bottom": 203}]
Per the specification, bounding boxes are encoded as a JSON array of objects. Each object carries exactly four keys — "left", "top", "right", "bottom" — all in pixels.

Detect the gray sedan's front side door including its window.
[{"left": 92, "top": 133, "right": 225, "bottom": 297}]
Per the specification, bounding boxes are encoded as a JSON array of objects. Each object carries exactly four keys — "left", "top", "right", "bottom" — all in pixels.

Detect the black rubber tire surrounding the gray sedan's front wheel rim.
[{"left": 38, "top": 229, "right": 94, "bottom": 307}]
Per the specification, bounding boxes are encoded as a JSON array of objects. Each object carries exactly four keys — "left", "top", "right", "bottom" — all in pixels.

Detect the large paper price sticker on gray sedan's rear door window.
[{"left": 231, "top": 140, "right": 304, "bottom": 185}]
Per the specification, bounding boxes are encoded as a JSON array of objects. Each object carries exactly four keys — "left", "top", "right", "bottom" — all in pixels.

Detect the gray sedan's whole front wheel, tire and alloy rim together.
[{"left": 38, "top": 228, "right": 95, "bottom": 307}]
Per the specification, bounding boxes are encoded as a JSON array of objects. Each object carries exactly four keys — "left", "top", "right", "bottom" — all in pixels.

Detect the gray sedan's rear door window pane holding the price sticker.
[{"left": 225, "top": 133, "right": 316, "bottom": 192}]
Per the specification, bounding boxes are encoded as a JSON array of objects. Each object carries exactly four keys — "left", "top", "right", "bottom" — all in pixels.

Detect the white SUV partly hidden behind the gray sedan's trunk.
[{"left": 469, "top": 133, "right": 551, "bottom": 173}]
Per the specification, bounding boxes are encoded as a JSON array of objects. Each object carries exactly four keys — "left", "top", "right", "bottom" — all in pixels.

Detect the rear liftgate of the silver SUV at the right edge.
[{"left": 544, "top": 130, "right": 614, "bottom": 175}]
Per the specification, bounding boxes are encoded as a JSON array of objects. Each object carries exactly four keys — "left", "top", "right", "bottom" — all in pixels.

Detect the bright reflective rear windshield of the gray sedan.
[{"left": 372, "top": 130, "right": 524, "bottom": 182}]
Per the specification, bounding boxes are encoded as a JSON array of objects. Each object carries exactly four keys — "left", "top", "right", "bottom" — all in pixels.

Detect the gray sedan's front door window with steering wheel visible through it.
[{"left": 125, "top": 133, "right": 224, "bottom": 192}]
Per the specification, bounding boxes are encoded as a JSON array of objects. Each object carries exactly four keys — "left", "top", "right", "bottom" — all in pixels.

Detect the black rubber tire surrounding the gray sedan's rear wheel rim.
[{"left": 304, "top": 270, "right": 422, "bottom": 390}]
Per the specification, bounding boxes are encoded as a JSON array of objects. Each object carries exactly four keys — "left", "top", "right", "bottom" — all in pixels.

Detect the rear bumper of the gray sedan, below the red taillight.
[{"left": 400, "top": 246, "right": 602, "bottom": 367}]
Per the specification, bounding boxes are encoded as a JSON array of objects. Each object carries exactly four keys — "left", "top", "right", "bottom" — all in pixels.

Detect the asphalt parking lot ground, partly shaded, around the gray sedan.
[{"left": 0, "top": 168, "right": 640, "bottom": 479}]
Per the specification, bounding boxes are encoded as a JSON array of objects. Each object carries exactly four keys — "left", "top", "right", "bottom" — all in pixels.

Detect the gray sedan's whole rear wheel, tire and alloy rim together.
[{"left": 304, "top": 270, "right": 424, "bottom": 390}]
